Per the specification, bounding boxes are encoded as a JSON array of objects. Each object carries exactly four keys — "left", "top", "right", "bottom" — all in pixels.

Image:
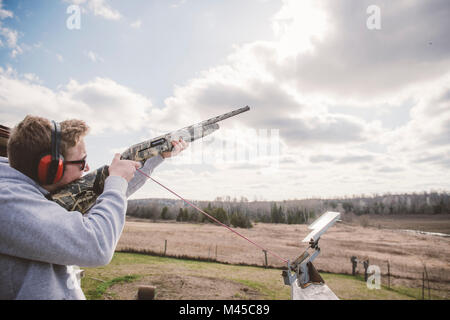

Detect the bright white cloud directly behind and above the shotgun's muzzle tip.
[{"left": 160, "top": 46, "right": 382, "bottom": 147}]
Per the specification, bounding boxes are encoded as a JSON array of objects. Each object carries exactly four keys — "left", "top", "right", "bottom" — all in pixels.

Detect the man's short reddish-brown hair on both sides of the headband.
[{"left": 7, "top": 115, "right": 89, "bottom": 181}]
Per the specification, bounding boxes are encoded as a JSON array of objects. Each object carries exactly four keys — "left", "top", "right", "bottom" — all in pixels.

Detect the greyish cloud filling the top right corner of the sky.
[{"left": 261, "top": 0, "right": 450, "bottom": 101}]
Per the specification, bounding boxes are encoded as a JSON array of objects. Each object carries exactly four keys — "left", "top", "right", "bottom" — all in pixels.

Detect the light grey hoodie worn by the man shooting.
[{"left": 0, "top": 156, "right": 163, "bottom": 300}]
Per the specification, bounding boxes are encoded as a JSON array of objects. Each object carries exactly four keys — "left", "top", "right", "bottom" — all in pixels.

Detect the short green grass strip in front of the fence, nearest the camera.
[{"left": 82, "top": 252, "right": 430, "bottom": 300}]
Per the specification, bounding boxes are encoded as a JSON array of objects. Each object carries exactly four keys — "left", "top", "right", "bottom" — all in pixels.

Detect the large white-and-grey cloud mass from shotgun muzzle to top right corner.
[{"left": 162, "top": 0, "right": 450, "bottom": 145}]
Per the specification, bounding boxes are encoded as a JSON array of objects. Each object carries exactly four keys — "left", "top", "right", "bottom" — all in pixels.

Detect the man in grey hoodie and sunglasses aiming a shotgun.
[{"left": 0, "top": 116, "right": 187, "bottom": 300}]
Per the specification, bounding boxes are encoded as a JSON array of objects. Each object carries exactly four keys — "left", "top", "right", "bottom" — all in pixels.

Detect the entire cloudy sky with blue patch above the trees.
[{"left": 0, "top": 0, "right": 450, "bottom": 200}]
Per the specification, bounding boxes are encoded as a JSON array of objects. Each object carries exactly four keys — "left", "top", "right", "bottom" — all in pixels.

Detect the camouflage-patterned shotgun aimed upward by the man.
[{"left": 51, "top": 106, "right": 250, "bottom": 214}]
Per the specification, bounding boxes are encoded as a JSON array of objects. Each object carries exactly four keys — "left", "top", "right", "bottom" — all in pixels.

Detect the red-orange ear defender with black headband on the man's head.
[{"left": 38, "top": 120, "right": 64, "bottom": 185}]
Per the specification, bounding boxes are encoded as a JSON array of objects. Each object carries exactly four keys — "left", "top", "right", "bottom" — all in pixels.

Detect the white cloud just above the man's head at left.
[{"left": 0, "top": 68, "right": 162, "bottom": 134}]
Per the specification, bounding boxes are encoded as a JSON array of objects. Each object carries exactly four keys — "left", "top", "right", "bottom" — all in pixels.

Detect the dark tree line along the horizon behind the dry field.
[{"left": 127, "top": 192, "right": 450, "bottom": 228}]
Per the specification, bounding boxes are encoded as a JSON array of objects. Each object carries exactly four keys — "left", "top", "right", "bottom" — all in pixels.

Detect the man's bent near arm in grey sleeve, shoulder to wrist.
[{"left": 0, "top": 176, "right": 127, "bottom": 267}]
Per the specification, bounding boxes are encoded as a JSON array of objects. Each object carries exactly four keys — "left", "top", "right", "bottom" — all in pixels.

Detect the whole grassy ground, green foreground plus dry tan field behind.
[{"left": 83, "top": 217, "right": 450, "bottom": 300}]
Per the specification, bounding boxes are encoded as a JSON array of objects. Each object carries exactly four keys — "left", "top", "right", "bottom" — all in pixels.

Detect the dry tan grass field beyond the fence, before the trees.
[{"left": 117, "top": 216, "right": 450, "bottom": 298}]
